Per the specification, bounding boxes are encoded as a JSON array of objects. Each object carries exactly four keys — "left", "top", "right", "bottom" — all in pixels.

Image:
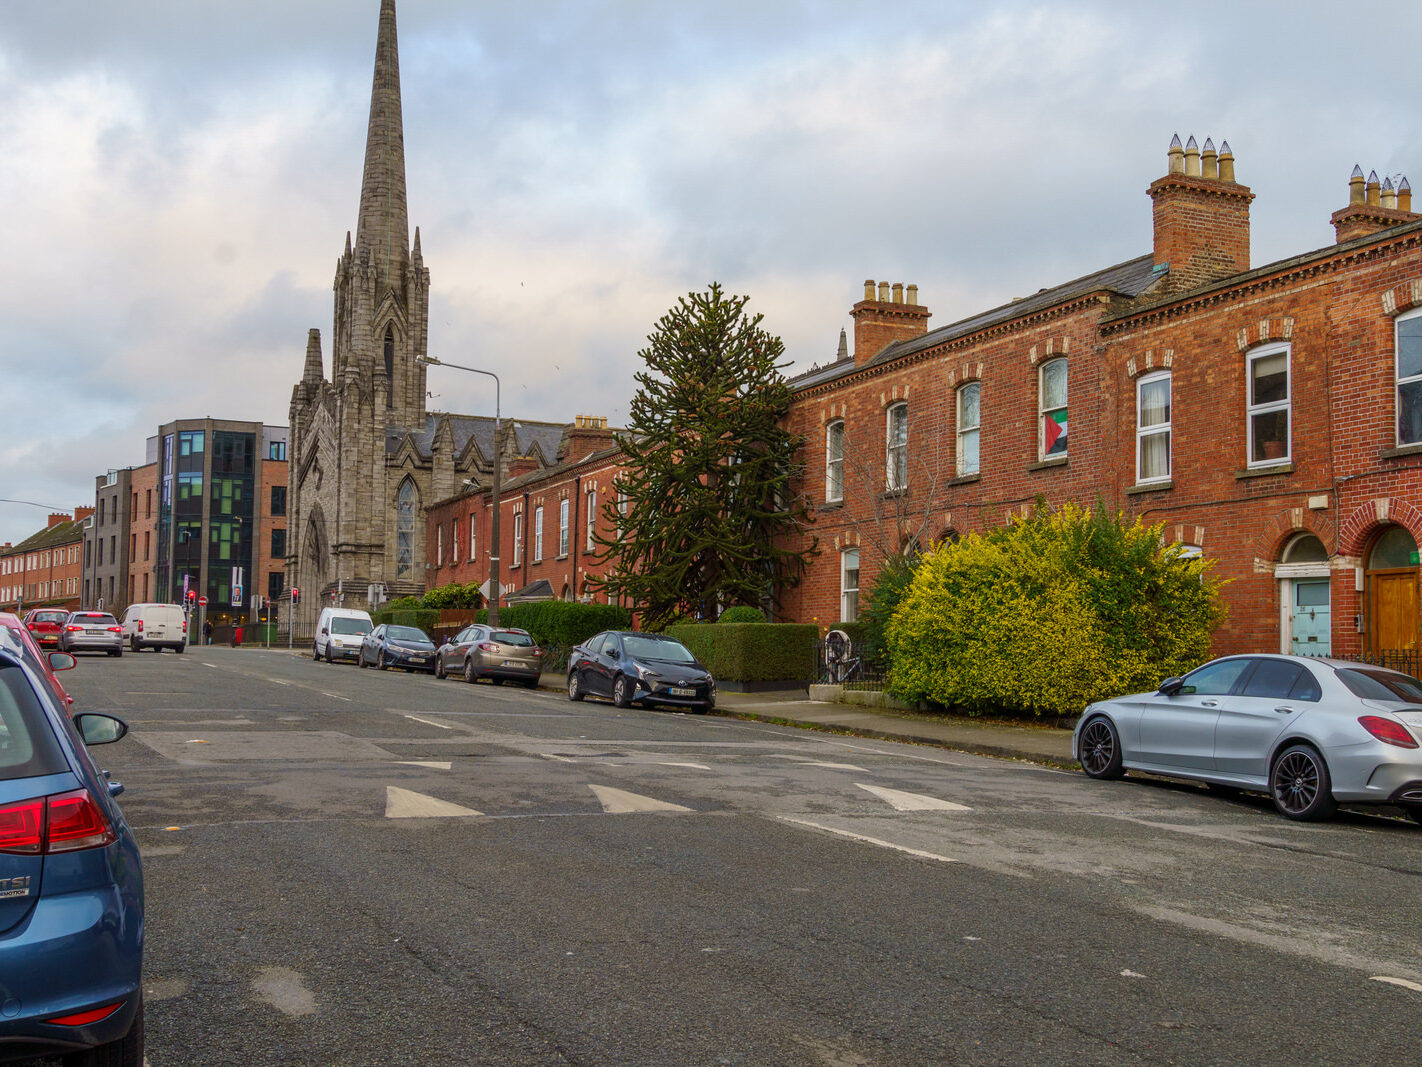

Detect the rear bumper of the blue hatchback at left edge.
[{"left": 0, "top": 886, "right": 144, "bottom": 1061}]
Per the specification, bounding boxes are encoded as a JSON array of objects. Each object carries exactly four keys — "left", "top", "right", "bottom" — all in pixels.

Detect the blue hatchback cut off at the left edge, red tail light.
[{"left": 0, "top": 636, "right": 144, "bottom": 1067}]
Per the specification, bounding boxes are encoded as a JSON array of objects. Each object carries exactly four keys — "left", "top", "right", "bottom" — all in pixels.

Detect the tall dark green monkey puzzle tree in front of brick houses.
[{"left": 596, "top": 283, "right": 813, "bottom": 629}]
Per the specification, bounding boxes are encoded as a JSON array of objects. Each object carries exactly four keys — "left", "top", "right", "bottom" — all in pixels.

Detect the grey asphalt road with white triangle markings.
[{"left": 41, "top": 647, "right": 1422, "bottom": 1067}]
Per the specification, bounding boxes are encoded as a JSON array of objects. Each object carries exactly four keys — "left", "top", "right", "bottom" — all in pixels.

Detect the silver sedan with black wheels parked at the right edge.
[{"left": 1072, "top": 656, "right": 1422, "bottom": 822}]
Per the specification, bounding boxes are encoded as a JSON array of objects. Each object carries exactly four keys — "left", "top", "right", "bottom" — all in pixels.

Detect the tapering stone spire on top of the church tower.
[{"left": 356, "top": 0, "right": 410, "bottom": 304}]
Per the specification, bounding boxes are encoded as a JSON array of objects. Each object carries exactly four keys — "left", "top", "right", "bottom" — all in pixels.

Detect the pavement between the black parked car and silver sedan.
[{"left": 717, "top": 690, "right": 1075, "bottom": 765}]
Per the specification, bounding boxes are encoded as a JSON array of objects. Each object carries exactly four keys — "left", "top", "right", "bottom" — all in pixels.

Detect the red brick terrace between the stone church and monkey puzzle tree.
[{"left": 425, "top": 415, "right": 621, "bottom": 603}]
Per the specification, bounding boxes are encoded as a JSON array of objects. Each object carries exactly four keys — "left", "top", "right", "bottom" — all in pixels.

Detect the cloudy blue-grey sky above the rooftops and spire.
[{"left": 0, "top": 0, "right": 1422, "bottom": 542}]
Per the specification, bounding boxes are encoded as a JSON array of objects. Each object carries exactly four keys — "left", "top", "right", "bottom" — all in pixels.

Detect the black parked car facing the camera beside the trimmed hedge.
[{"left": 567, "top": 630, "right": 715, "bottom": 711}]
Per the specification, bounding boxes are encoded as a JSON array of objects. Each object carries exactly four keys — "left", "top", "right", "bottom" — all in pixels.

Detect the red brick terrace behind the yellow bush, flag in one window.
[{"left": 785, "top": 138, "right": 1422, "bottom": 654}]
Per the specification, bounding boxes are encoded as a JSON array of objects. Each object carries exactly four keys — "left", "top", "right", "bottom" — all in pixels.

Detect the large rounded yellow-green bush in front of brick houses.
[{"left": 886, "top": 505, "right": 1224, "bottom": 716}]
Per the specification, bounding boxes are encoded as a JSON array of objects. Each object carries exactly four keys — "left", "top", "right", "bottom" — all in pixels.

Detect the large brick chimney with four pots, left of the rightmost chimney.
[{"left": 1148, "top": 134, "right": 1254, "bottom": 293}]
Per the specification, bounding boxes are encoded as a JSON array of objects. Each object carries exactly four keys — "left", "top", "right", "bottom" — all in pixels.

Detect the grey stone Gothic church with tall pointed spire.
[{"left": 286, "top": 0, "right": 566, "bottom": 635}]
